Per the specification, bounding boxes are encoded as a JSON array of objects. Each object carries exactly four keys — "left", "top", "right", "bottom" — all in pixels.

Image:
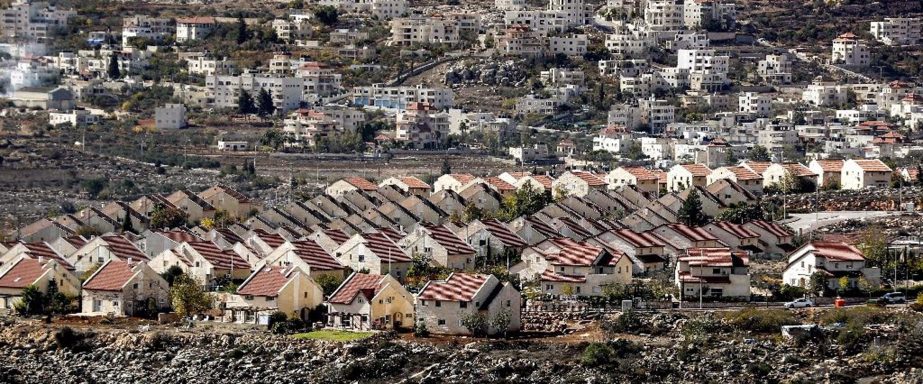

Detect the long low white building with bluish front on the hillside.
[{"left": 352, "top": 84, "right": 455, "bottom": 110}]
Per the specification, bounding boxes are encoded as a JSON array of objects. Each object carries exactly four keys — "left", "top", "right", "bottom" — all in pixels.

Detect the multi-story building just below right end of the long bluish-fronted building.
[{"left": 394, "top": 103, "right": 449, "bottom": 148}]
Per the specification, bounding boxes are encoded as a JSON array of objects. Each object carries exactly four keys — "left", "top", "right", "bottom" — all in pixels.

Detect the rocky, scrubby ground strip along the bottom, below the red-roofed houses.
[{"left": 0, "top": 308, "right": 923, "bottom": 383}]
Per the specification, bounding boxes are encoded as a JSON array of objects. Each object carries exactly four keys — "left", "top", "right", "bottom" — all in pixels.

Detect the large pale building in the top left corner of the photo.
[{"left": 0, "top": 0, "right": 77, "bottom": 42}]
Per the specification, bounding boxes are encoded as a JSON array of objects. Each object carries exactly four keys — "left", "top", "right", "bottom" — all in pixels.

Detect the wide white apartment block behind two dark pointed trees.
[{"left": 205, "top": 72, "right": 304, "bottom": 112}]
